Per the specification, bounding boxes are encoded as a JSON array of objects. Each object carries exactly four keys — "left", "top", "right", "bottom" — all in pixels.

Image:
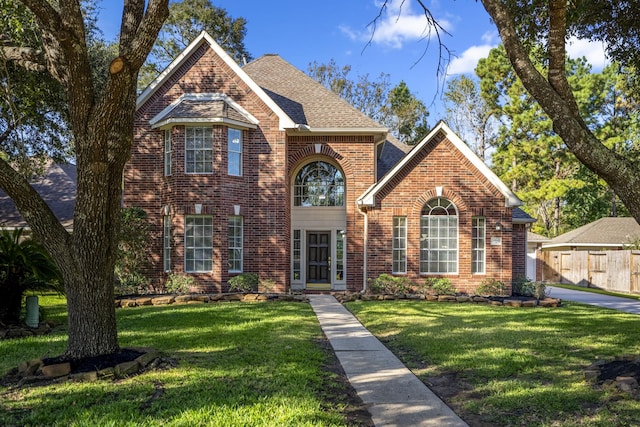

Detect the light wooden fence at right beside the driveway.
[{"left": 539, "top": 250, "right": 640, "bottom": 293}]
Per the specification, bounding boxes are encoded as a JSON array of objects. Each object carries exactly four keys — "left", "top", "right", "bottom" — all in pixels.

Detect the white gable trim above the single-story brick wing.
[{"left": 357, "top": 120, "right": 522, "bottom": 207}]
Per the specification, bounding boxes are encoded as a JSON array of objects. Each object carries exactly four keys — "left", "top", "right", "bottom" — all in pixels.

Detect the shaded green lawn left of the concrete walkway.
[{"left": 0, "top": 299, "right": 352, "bottom": 426}]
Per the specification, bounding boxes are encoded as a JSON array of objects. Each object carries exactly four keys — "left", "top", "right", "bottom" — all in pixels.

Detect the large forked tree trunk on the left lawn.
[{"left": 0, "top": 0, "right": 169, "bottom": 358}]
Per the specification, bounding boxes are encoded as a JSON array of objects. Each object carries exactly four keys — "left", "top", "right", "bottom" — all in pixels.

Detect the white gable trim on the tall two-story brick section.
[{"left": 136, "top": 31, "right": 295, "bottom": 130}]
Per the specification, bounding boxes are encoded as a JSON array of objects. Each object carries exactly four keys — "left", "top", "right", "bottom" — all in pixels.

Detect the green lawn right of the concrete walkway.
[{"left": 346, "top": 301, "right": 640, "bottom": 427}]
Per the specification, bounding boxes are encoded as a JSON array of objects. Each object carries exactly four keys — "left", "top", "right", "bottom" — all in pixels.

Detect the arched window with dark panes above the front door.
[{"left": 293, "top": 161, "right": 344, "bottom": 206}]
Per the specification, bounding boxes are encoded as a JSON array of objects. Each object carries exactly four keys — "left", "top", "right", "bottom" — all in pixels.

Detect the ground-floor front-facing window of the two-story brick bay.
[{"left": 184, "top": 215, "right": 213, "bottom": 273}]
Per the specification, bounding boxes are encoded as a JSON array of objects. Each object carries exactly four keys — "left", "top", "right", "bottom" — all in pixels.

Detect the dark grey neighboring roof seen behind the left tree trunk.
[{"left": 0, "top": 162, "right": 77, "bottom": 231}]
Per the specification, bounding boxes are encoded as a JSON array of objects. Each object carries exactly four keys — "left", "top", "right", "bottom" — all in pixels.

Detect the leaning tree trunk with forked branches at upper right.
[{"left": 482, "top": 0, "right": 640, "bottom": 226}]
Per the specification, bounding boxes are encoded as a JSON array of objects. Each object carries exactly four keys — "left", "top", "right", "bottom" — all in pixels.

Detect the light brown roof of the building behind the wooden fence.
[{"left": 542, "top": 217, "right": 640, "bottom": 249}]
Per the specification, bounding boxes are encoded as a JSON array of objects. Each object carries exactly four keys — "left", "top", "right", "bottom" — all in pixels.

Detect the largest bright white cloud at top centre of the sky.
[{"left": 340, "top": 0, "right": 451, "bottom": 49}]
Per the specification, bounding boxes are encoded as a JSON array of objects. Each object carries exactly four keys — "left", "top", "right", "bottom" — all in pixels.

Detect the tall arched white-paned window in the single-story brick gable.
[{"left": 420, "top": 197, "right": 458, "bottom": 274}]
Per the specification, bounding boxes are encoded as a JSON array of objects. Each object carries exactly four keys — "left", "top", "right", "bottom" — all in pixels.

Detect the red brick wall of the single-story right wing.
[{"left": 368, "top": 135, "right": 524, "bottom": 292}]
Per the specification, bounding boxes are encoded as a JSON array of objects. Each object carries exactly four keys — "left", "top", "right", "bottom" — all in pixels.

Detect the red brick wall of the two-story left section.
[{"left": 124, "top": 45, "right": 290, "bottom": 292}]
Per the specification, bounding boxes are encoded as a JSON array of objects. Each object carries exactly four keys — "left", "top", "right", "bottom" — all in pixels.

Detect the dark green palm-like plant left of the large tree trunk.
[{"left": 0, "top": 228, "right": 63, "bottom": 324}]
